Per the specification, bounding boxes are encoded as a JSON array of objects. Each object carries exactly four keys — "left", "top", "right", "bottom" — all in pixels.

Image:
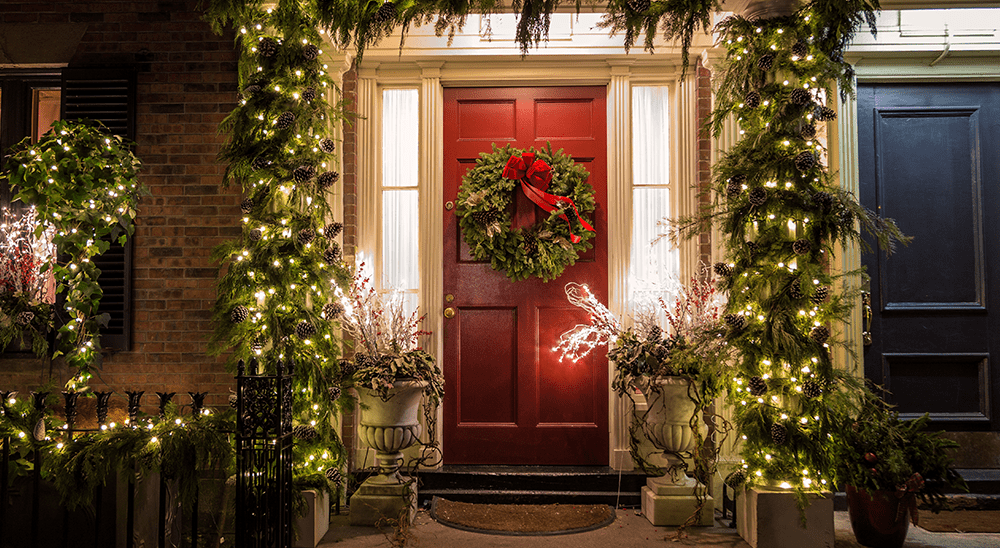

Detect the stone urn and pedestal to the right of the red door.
[{"left": 642, "top": 377, "right": 714, "bottom": 526}]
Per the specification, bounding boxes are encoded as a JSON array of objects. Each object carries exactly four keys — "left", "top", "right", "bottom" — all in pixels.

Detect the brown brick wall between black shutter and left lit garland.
[{"left": 0, "top": 0, "right": 240, "bottom": 411}]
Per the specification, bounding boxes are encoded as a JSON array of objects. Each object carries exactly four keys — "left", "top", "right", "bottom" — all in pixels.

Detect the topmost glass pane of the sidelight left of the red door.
[{"left": 382, "top": 89, "right": 420, "bottom": 187}]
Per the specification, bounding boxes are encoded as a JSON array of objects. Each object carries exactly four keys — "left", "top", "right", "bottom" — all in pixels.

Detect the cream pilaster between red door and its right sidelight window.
[{"left": 601, "top": 59, "right": 634, "bottom": 470}]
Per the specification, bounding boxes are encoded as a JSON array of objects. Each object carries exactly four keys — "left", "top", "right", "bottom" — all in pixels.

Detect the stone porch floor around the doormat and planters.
[{"left": 318, "top": 510, "right": 1000, "bottom": 548}]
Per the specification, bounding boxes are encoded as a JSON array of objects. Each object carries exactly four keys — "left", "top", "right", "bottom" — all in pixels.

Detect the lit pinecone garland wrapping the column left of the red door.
[{"left": 207, "top": 1, "right": 350, "bottom": 487}]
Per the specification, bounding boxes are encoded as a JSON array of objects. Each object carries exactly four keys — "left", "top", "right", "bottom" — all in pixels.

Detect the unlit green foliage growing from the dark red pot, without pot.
[{"left": 836, "top": 390, "right": 968, "bottom": 524}]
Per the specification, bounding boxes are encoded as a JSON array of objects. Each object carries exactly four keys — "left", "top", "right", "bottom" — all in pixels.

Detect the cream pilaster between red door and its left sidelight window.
[{"left": 418, "top": 61, "right": 444, "bottom": 466}]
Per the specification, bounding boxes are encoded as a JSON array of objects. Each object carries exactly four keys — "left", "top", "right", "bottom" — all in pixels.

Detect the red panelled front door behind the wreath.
[{"left": 443, "top": 87, "right": 608, "bottom": 465}]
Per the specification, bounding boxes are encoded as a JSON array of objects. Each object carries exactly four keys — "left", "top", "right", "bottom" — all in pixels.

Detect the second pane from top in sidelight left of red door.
[{"left": 382, "top": 190, "right": 420, "bottom": 290}]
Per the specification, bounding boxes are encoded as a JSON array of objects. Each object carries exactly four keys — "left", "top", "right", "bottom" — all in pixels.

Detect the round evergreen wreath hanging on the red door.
[{"left": 455, "top": 144, "right": 597, "bottom": 282}]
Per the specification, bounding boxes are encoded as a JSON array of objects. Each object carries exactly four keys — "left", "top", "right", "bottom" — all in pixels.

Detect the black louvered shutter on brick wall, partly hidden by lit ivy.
[{"left": 62, "top": 68, "right": 136, "bottom": 351}]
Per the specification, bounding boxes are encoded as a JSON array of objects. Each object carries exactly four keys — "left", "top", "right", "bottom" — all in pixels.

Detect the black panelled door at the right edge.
[{"left": 858, "top": 83, "right": 1000, "bottom": 439}]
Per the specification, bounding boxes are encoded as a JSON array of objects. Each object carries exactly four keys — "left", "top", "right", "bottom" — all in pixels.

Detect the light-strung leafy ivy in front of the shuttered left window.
[{"left": 4, "top": 120, "right": 149, "bottom": 390}]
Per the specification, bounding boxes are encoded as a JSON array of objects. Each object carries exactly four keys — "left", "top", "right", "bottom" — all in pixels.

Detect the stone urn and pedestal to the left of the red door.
[{"left": 350, "top": 380, "right": 428, "bottom": 525}]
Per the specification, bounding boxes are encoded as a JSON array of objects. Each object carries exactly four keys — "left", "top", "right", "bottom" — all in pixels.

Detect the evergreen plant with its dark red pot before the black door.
[{"left": 835, "top": 391, "right": 967, "bottom": 548}]
